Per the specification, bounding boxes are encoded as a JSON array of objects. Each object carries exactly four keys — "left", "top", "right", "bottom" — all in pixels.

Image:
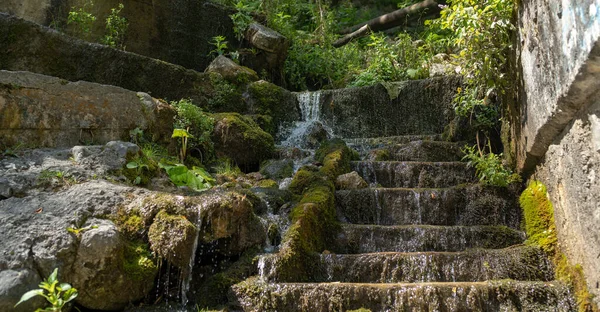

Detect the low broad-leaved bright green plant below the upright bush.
[{"left": 158, "top": 163, "right": 215, "bottom": 191}]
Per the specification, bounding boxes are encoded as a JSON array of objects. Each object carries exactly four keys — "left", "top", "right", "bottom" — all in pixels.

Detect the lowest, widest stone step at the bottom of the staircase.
[{"left": 233, "top": 278, "right": 577, "bottom": 312}]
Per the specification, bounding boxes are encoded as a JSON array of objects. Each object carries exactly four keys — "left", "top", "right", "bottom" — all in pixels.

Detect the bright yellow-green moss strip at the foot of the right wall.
[{"left": 519, "top": 181, "right": 598, "bottom": 312}]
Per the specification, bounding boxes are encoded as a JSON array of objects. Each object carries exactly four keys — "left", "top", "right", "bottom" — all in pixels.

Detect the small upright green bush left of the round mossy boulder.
[{"left": 171, "top": 99, "right": 214, "bottom": 162}]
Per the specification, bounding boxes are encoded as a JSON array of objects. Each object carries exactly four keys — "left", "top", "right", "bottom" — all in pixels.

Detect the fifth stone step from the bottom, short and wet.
[{"left": 351, "top": 161, "right": 476, "bottom": 188}]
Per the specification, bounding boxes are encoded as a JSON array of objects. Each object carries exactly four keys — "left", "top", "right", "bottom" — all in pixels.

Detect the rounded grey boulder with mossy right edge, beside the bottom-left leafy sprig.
[{"left": 71, "top": 220, "right": 157, "bottom": 310}]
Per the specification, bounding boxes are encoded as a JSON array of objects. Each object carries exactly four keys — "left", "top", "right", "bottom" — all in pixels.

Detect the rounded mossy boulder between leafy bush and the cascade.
[{"left": 212, "top": 113, "right": 275, "bottom": 172}]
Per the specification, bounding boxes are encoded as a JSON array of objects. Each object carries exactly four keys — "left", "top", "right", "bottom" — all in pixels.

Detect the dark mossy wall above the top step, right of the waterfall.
[{"left": 320, "top": 77, "right": 461, "bottom": 138}]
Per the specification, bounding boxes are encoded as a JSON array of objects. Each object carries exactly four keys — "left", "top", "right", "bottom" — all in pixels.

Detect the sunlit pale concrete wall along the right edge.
[{"left": 512, "top": 0, "right": 600, "bottom": 303}]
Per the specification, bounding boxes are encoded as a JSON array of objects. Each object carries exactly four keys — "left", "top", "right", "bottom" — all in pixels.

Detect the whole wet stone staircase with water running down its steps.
[{"left": 232, "top": 135, "right": 576, "bottom": 311}]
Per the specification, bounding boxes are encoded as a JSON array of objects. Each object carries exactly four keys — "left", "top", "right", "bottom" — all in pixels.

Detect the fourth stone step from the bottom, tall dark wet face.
[{"left": 335, "top": 185, "right": 521, "bottom": 228}]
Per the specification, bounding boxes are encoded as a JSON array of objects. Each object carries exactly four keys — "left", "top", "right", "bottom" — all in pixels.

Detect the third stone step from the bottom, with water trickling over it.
[{"left": 331, "top": 224, "right": 525, "bottom": 254}]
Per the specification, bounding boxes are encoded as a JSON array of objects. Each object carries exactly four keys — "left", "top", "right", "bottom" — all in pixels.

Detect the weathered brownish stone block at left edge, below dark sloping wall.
[{"left": 0, "top": 71, "right": 174, "bottom": 147}]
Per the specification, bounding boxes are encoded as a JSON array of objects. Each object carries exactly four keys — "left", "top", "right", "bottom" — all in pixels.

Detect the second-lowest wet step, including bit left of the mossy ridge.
[{"left": 259, "top": 245, "right": 554, "bottom": 283}]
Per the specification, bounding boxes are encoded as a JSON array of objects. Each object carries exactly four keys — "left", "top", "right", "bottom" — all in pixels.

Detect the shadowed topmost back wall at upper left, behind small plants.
[{"left": 0, "top": 0, "right": 238, "bottom": 70}]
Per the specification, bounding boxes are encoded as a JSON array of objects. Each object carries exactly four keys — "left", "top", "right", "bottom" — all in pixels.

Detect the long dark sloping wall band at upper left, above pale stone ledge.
[{"left": 0, "top": 13, "right": 212, "bottom": 104}]
